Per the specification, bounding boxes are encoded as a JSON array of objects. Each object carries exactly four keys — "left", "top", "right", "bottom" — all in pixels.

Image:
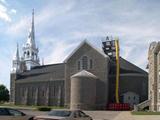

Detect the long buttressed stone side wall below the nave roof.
[{"left": 16, "top": 80, "right": 64, "bottom": 106}]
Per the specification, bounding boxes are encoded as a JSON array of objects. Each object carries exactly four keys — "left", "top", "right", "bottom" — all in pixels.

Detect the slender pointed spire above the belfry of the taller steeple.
[{"left": 27, "top": 9, "right": 36, "bottom": 48}]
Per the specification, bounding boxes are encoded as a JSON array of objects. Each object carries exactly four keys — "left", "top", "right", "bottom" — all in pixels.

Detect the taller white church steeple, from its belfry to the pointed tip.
[{"left": 23, "top": 9, "right": 40, "bottom": 70}]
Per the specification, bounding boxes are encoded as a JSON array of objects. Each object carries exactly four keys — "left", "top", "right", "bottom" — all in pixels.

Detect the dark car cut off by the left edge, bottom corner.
[{"left": 0, "top": 107, "right": 33, "bottom": 120}]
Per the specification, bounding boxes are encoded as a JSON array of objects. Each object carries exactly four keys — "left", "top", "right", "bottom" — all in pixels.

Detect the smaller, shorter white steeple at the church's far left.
[{"left": 11, "top": 43, "right": 20, "bottom": 73}]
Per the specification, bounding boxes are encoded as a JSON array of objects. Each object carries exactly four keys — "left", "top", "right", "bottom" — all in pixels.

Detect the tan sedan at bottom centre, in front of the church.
[{"left": 34, "top": 110, "right": 92, "bottom": 120}]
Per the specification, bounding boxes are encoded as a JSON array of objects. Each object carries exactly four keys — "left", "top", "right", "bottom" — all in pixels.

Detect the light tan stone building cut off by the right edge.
[{"left": 148, "top": 42, "right": 160, "bottom": 111}]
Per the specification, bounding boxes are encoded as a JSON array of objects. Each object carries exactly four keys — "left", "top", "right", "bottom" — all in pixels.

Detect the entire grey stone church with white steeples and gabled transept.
[{"left": 10, "top": 11, "right": 148, "bottom": 109}]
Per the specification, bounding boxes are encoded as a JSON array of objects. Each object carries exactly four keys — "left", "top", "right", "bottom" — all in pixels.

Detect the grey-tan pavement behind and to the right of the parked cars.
[{"left": 21, "top": 110, "right": 160, "bottom": 120}]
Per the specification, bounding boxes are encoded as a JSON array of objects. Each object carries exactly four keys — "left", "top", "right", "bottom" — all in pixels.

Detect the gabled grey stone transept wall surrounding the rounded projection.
[{"left": 65, "top": 43, "right": 109, "bottom": 107}]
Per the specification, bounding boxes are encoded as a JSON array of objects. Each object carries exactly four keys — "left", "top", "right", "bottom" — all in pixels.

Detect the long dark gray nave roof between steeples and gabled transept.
[{"left": 17, "top": 63, "right": 65, "bottom": 82}]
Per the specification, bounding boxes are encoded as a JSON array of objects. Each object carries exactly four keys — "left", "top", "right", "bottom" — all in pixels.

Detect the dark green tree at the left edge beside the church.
[{"left": 0, "top": 85, "right": 9, "bottom": 102}]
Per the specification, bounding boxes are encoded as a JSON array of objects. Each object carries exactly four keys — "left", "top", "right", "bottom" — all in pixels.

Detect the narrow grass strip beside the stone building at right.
[{"left": 131, "top": 111, "right": 160, "bottom": 115}]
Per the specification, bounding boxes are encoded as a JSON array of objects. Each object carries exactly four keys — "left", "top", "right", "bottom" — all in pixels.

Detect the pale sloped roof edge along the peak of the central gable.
[{"left": 64, "top": 40, "right": 108, "bottom": 63}]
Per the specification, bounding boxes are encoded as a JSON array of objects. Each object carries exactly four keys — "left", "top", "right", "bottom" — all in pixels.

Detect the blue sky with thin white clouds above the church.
[{"left": 0, "top": 0, "right": 160, "bottom": 88}]
